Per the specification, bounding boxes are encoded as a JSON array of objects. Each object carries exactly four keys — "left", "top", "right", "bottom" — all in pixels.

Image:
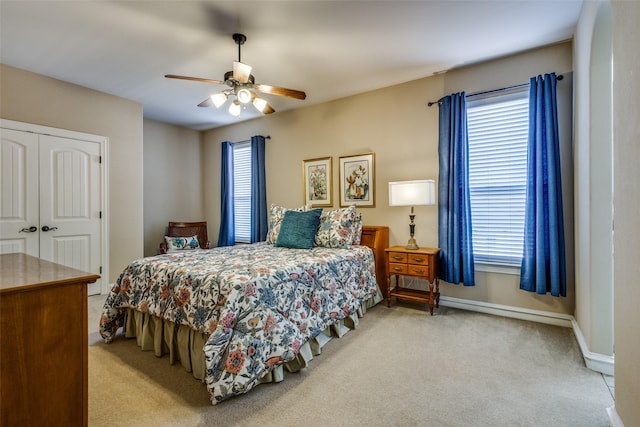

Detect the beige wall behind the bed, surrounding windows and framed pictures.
[{"left": 203, "top": 42, "right": 574, "bottom": 315}]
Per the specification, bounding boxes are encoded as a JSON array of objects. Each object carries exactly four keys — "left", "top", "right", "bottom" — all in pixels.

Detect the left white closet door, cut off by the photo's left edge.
[{"left": 0, "top": 129, "right": 40, "bottom": 257}]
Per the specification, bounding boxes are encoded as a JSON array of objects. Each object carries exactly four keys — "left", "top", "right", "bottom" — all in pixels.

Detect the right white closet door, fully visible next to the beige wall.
[{"left": 40, "top": 135, "right": 101, "bottom": 295}]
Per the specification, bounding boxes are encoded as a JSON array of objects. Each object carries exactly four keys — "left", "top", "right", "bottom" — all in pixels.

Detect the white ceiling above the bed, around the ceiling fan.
[{"left": 0, "top": 0, "right": 582, "bottom": 130}]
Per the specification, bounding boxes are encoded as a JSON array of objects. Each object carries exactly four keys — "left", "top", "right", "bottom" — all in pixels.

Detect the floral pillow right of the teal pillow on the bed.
[{"left": 315, "top": 205, "right": 362, "bottom": 248}]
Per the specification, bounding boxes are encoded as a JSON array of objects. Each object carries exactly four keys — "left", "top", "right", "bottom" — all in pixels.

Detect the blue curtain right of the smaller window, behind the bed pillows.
[{"left": 251, "top": 135, "right": 268, "bottom": 243}]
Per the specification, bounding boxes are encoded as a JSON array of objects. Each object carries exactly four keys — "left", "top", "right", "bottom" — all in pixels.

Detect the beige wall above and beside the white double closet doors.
[{"left": 0, "top": 65, "right": 143, "bottom": 283}]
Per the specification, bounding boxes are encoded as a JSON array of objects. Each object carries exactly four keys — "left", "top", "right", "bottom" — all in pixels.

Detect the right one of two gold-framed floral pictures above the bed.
[{"left": 340, "top": 153, "right": 376, "bottom": 208}]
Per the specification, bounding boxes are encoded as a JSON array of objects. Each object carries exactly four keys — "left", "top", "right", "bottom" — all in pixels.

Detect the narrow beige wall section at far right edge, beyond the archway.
[{"left": 612, "top": 0, "right": 640, "bottom": 427}]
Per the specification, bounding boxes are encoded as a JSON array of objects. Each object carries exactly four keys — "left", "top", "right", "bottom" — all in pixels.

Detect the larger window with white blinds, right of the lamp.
[{"left": 467, "top": 86, "right": 529, "bottom": 267}]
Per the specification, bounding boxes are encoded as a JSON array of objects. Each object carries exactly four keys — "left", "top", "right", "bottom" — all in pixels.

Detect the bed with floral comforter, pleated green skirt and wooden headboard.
[{"left": 100, "top": 206, "right": 388, "bottom": 404}]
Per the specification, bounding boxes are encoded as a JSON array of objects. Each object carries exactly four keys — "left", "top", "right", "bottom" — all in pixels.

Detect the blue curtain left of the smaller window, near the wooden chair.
[{"left": 218, "top": 141, "right": 236, "bottom": 246}]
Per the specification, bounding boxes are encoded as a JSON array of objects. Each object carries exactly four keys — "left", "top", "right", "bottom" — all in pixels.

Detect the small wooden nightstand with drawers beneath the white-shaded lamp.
[{"left": 385, "top": 246, "right": 440, "bottom": 316}]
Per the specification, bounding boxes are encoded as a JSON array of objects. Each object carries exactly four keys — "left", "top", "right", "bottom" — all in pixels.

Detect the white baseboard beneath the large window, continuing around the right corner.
[{"left": 440, "top": 296, "right": 614, "bottom": 375}]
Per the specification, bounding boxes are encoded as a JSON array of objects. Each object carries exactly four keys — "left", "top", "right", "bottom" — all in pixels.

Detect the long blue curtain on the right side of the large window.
[{"left": 520, "top": 73, "right": 567, "bottom": 297}]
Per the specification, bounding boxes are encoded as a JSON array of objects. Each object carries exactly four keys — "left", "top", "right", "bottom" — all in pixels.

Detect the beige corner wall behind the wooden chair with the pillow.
[{"left": 144, "top": 120, "right": 204, "bottom": 256}]
